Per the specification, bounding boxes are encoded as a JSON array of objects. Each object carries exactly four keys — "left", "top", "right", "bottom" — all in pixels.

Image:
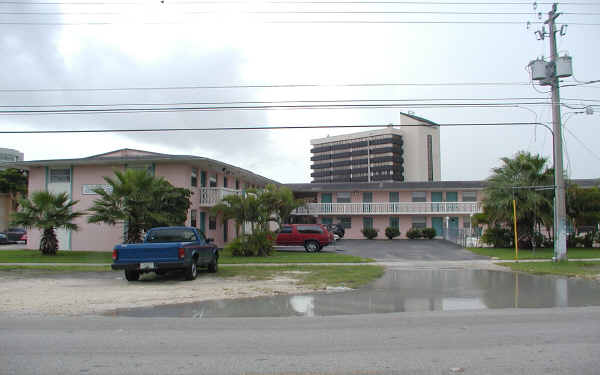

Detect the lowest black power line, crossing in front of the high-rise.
[{"left": 0, "top": 122, "right": 540, "bottom": 134}]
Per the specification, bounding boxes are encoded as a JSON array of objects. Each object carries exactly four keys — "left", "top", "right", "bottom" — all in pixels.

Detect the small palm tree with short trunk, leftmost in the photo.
[{"left": 12, "top": 191, "right": 83, "bottom": 255}]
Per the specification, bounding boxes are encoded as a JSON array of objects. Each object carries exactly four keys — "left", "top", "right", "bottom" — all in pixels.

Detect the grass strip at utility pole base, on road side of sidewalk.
[{"left": 500, "top": 261, "right": 600, "bottom": 277}]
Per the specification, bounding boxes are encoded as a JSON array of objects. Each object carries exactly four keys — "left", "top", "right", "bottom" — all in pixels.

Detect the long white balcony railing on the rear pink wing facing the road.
[{"left": 292, "top": 202, "right": 482, "bottom": 215}]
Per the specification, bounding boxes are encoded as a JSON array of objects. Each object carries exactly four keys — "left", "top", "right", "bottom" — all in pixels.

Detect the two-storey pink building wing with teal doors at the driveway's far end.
[{"left": 287, "top": 181, "right": 484, "bottom": 238}]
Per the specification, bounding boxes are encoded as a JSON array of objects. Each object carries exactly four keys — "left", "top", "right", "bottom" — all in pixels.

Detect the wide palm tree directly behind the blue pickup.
[{"left": 88, "top": 169, "right": 192, "bottom": 243}]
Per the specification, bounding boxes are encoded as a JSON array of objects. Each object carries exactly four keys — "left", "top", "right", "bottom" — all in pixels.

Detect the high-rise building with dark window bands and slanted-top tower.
[{"left": 311, "top": 113, "right": 441, "bottom": 183}]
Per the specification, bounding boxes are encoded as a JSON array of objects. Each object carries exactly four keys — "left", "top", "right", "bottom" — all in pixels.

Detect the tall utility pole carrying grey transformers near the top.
[{"left": 529, "top": 3, "right": 573, "bottom": 261}]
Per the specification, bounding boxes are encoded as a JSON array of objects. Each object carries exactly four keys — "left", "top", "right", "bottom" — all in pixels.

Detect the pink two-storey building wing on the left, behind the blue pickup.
[{"left": 14, "top": 149, "right": 277, "bottom": 251}]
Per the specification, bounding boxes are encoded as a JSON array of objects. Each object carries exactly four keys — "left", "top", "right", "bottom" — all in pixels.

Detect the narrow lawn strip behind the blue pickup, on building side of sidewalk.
[{"left": 0, "top": 250, "right": 373, "bottom": 264}]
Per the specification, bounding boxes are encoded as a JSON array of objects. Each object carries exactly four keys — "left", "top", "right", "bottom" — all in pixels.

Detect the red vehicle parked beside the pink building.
[{"left": 275, "top": 224, "right": 333, "bottom": 253}]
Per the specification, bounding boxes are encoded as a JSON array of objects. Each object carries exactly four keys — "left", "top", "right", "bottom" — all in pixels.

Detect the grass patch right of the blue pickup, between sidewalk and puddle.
[{"left": 217, "top": 265, "right": 384, "bottom": 289}]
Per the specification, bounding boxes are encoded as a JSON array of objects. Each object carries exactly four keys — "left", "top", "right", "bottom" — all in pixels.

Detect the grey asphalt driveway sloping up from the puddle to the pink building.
[{"left": 336, "top": 239, "right": 490, "bottom": 261}]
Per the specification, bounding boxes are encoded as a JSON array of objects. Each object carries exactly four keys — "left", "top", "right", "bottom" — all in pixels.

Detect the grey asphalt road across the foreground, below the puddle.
[{"left": 0, "top": 307, "right": 600, "bottom": 375}]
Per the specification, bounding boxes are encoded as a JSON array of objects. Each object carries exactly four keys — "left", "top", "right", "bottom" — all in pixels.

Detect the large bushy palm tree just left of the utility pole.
[{"left": 483, "top": 151, "right": 554, "bottom": 248}]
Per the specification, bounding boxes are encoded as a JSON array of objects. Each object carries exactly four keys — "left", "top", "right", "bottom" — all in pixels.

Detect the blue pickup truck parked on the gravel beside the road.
[{"left": 111, "top": 227, "right": 219, "bottom": 281}]
